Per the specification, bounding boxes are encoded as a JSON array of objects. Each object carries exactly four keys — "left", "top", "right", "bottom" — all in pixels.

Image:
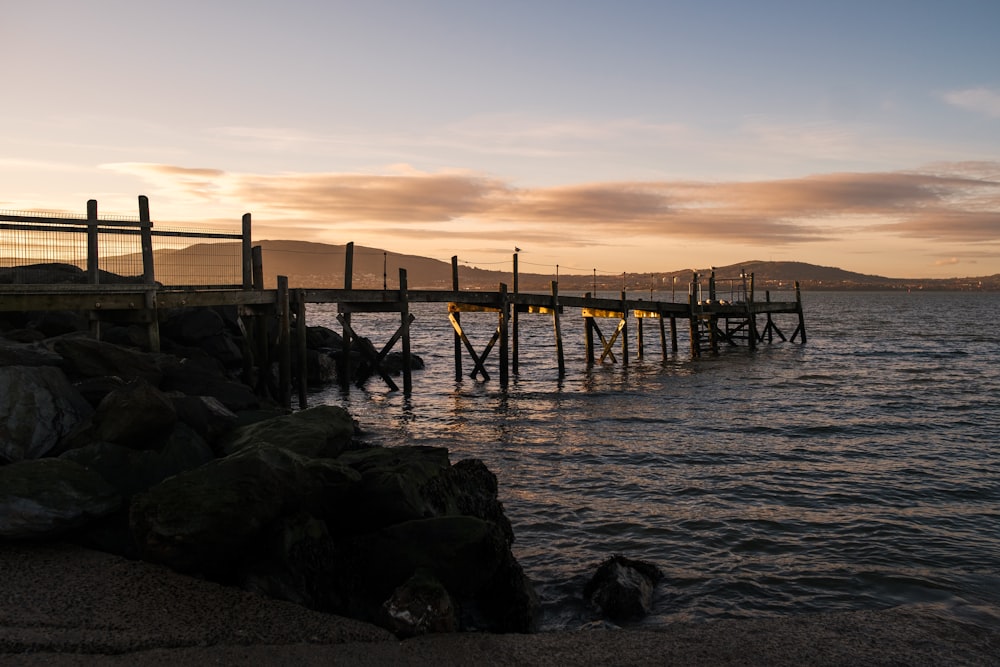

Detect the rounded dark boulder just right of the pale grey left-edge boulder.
[{"left": 94, "top": 379, "right": 177, "bottom": 449}]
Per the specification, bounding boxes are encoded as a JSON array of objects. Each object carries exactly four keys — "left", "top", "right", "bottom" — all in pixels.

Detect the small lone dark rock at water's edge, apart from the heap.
[{"left": 583, "top": 554, "right": 663, "bottom": 621}]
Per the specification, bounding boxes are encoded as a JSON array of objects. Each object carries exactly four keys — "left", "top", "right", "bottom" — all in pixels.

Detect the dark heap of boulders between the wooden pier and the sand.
[{"left": 0, "top": 300, "right": 540, "bottom": 637}]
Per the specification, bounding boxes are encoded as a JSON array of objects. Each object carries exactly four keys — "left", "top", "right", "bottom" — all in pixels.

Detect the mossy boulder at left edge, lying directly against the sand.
[{"left": 0, "top": 458, "right": 122, "bottom": 539}]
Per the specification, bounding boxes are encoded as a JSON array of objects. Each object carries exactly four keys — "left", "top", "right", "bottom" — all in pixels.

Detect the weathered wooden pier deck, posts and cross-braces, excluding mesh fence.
[{"left": 0, "top": 197, "right": 806, "bottom": 407}]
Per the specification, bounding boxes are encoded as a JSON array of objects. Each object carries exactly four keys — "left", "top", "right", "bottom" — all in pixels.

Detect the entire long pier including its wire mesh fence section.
[{"left": 0, "top": 197, "right": 806, "bottom": 407}]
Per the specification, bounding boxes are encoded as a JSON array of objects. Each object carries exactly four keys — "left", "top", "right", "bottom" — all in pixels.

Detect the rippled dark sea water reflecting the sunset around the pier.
[{"left": 310, "top": 293, "right": 1000, "bottom": 629}]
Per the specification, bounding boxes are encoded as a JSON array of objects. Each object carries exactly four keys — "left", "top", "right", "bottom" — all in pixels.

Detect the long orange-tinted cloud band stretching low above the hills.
[{"left": 109, "top": 162, "right": 1000, "bottom": 247}]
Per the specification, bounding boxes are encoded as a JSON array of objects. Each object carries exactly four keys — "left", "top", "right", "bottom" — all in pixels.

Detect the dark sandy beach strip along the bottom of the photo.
[{"left": 0, "top": 544, "right": 1000, "bottom": 667}]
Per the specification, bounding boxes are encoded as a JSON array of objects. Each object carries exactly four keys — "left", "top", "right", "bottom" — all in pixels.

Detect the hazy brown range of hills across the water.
[{"left": 145, "top": 240, "right": 1000, "bottom": 292}]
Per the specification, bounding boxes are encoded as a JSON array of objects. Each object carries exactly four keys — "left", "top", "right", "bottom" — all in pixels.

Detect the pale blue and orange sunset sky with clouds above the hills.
[{"left": 0, "top": 0, "right": 1000, "bottom": 278}]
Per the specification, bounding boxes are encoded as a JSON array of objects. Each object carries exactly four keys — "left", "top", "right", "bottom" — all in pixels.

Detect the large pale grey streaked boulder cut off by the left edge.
[{"left": 0, "top": 366, "right": 93, "bottom": 461}]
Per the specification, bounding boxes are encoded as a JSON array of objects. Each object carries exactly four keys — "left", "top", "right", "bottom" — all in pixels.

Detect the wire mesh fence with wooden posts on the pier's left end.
[{"left": 0, "top": 197, "right": 251, "bottom": 289}]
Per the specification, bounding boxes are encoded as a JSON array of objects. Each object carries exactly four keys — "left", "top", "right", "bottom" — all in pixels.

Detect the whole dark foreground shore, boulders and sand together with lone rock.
[{"left": 0, "top": 298, "right": 1000, "bottom": 665}]
